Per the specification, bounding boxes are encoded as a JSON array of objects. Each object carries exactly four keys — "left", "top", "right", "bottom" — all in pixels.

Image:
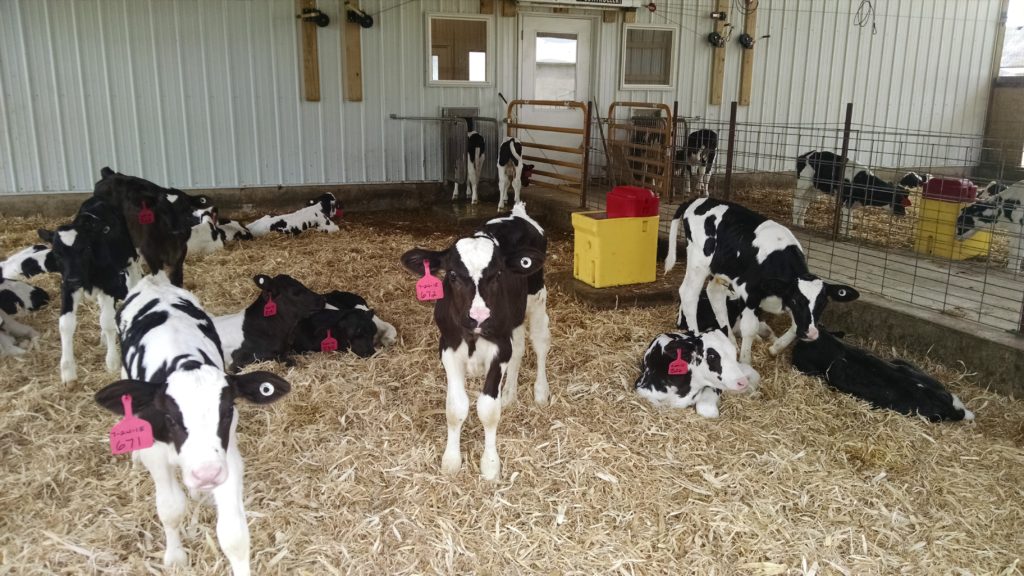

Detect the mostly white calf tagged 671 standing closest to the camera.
[{"left": 95, "top": 273, "right": 291, "bottom": 576}]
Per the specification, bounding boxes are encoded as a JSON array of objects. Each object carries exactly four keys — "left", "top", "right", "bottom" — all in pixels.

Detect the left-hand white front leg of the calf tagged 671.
[{"left": 138, "top": 442, "right": 188, "bottom": 566}]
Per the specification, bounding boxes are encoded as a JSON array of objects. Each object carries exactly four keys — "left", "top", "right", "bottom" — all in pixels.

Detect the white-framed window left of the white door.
[{"left": 427, "top": 15, "right": 494, "bottom": 85}]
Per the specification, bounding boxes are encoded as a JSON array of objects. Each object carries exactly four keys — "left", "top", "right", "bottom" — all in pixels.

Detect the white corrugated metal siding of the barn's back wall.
[{"left": 0, "top": 0, "right": 999, "bottom": 194}]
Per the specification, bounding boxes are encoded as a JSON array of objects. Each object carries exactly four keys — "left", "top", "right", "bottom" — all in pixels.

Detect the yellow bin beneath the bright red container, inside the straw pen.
[{"left": 572, "top": 212, "right": 658, "bottom": 288}]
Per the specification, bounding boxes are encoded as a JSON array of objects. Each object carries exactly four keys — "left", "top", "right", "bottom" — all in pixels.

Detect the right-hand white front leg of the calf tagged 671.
[{"left": 213, "top": 436, "right": 249, "bottom": 576}]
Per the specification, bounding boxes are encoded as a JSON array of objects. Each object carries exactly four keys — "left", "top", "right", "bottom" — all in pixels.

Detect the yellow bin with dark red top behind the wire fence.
[{"left": 913, "top": 178, "right": 991, "bottom": 260}]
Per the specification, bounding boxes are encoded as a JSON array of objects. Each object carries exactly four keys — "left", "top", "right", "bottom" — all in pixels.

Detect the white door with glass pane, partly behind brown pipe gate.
[{"left": 518, "top": 15, "right": 594, "bottom": 189}]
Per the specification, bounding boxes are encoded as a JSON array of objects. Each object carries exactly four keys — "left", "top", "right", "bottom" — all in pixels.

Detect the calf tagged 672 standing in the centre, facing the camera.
[{"left": 401, "top": 203, "right": 551, "bottom": 480}]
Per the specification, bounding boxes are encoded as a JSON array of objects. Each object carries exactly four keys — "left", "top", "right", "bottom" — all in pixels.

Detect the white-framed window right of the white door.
[{"left": 622, "top": 25, "right": 676, "bottom": 90}]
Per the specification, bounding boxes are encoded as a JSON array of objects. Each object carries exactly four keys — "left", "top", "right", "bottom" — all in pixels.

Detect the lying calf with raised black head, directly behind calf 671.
[{"left": 213, "top": 274, "right": 324, "bottom": 372}]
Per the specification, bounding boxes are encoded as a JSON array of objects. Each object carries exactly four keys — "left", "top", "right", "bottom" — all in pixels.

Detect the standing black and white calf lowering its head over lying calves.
[{"left": 665, "top": 198, "right": 856, "bottom": 364}]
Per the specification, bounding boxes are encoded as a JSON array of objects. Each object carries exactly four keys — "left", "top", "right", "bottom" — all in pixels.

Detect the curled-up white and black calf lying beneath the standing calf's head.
[{"left": 633, "top": 330, "right": 761, "bottom": 418}]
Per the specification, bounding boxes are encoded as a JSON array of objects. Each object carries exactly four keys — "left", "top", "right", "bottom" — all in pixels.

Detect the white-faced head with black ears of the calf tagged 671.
[{"left": 95, "top": 363, "right": 291, "bottom": 491}]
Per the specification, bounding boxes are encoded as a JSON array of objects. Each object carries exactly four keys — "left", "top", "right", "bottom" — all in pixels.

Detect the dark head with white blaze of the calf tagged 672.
[{"left": 401, "top": 234, "right": 545, "bottom": 334}]
